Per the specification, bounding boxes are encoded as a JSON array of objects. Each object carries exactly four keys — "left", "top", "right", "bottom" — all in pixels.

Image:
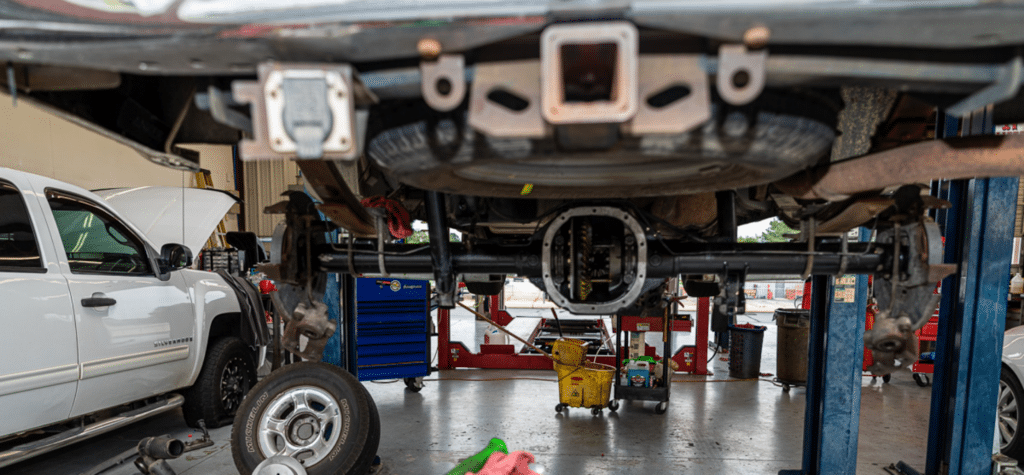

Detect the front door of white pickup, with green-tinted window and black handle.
[{"left": 40, "top": 188, "right": 196, "bottom": 416}]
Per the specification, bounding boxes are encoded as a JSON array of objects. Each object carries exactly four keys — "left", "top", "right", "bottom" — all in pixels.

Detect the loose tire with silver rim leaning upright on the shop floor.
[{"left": 231, "top": 362, "right": 380, "bottom": 475}]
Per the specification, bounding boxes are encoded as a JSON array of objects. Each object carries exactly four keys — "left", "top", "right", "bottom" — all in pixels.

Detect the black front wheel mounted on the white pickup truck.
[{"left": 181, "top": 337, "right": 256, "bottom": 429}]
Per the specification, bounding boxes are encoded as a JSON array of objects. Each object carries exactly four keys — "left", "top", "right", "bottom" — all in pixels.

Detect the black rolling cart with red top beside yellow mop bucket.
[{"left": 610, "top": 310, "right": 690, "bottom": 414}]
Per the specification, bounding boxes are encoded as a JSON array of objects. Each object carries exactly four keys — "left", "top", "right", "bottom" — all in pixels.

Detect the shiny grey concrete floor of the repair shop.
[{"left": 3, "top": 309, "right": 931, "bottom": 475}]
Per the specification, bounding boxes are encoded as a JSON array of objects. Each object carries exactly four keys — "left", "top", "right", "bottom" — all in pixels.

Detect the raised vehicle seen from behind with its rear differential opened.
[{"left": 0, "top": 0, "right": 1024, "bottom": 471}]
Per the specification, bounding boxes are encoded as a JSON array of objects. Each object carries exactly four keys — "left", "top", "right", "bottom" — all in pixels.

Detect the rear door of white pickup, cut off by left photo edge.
[{"left": 0, "top": 178, "right": 79, "bottom": 436}]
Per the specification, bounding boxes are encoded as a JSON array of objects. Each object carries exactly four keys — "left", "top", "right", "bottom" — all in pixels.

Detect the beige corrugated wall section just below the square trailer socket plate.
[{"left": 244, "top": 160, "right": 301, "bottom": 238}]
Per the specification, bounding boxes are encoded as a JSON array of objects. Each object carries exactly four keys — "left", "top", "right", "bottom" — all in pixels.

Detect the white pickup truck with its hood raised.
[{"left": 0, "top": 168, "right": 267, "bottom": 468}]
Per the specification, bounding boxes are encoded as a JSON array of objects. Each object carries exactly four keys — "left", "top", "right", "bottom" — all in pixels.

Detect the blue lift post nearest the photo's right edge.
[{"left": 925, "top": 107, "right": 1018, "bottom": 475}]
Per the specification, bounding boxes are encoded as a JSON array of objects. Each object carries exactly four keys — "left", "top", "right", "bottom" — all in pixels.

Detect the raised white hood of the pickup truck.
[{"left": 93, "top": 186, "right": 241, "bottom": 255}]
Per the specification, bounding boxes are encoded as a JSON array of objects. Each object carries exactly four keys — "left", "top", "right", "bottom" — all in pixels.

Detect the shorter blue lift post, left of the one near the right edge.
[{"left": 779, "top": 228, "right": 869, "bottom": 475}]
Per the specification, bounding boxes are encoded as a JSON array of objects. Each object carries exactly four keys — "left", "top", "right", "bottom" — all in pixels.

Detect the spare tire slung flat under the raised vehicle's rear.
[{"left": 366, "top": 90, "right": 841, "bottom": 199}]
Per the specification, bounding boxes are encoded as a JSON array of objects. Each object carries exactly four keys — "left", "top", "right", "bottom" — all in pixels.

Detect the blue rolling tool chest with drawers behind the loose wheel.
[{"left": 341, "top": 275, "right": 430, "bottom": 392}]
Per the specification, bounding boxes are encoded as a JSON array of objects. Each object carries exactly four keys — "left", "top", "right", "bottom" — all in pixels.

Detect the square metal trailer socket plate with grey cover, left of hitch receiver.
[{"left": 232, "top": 62, "right": 358, "bottom": 160}]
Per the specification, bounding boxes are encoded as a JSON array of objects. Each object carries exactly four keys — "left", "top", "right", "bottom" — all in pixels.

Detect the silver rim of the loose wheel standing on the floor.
[{"left": 259, "top": 386, "right": 347, "bottom": 467}]
